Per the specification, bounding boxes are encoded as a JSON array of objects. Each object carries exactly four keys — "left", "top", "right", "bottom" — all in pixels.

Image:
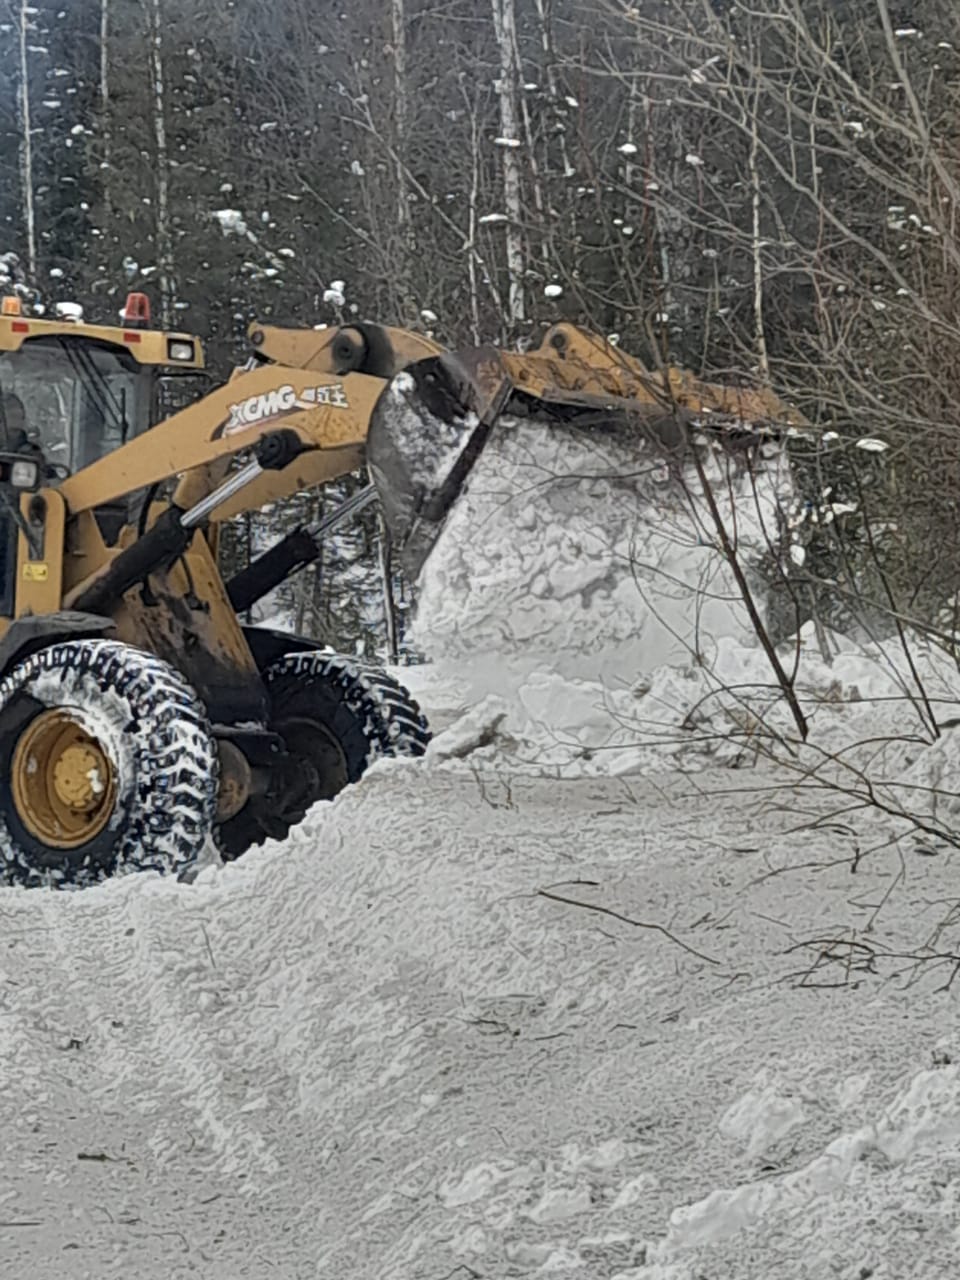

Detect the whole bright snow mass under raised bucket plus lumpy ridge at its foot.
[{"left": 399, "top": 421, "right": 960, "bottom": 776}]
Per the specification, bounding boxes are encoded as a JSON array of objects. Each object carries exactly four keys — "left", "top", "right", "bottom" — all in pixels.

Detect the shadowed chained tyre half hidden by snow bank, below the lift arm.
[{"left": 219, "top": 650, "right": 430, "bottom": 858}]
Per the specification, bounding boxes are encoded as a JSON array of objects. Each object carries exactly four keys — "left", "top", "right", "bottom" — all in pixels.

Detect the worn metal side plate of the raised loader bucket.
[{"left": 366, "top": 347, "right": 513, "bottom": 580}]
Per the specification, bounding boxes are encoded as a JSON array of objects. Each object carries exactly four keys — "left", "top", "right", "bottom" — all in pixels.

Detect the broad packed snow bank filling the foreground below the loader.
[{"left": 0, "top": 763, "right": 960, "bottom": 1280}]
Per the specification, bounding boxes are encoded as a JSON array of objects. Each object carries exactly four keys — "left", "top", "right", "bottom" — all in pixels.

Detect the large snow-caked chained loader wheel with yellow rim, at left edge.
[{"left": 0, "top": 640, "right": 219, "bottom": 886}]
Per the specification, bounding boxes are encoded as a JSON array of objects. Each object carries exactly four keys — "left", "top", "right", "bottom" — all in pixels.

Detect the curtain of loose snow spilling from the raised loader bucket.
[{"left": 413, "top": 420, "right": 790, "bottom": 682}]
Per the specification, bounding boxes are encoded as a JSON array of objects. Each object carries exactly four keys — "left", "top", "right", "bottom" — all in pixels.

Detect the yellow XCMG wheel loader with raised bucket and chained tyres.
[{"left": 0, "top": 296, "right": 800, "bottom": 886}]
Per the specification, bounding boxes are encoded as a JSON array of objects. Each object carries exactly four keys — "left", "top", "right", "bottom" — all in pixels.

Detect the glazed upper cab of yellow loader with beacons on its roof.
[{"left": 0, "top": 294, "right": 204, "bottom": 484}]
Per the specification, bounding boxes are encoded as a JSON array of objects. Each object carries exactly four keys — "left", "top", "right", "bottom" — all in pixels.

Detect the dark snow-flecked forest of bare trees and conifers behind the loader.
[{"left": 0, "top": 0, "right": 960, "bottom": 649}]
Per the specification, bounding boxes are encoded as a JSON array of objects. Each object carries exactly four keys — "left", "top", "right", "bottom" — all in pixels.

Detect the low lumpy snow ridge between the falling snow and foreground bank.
[{"left": 407, "top": 626, "right": 960, "bottom": 790}]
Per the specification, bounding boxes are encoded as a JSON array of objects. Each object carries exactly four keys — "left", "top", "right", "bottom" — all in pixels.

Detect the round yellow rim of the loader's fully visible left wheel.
[{"left": 10, "top": 708, "right": 116, "bottom": 849}]
